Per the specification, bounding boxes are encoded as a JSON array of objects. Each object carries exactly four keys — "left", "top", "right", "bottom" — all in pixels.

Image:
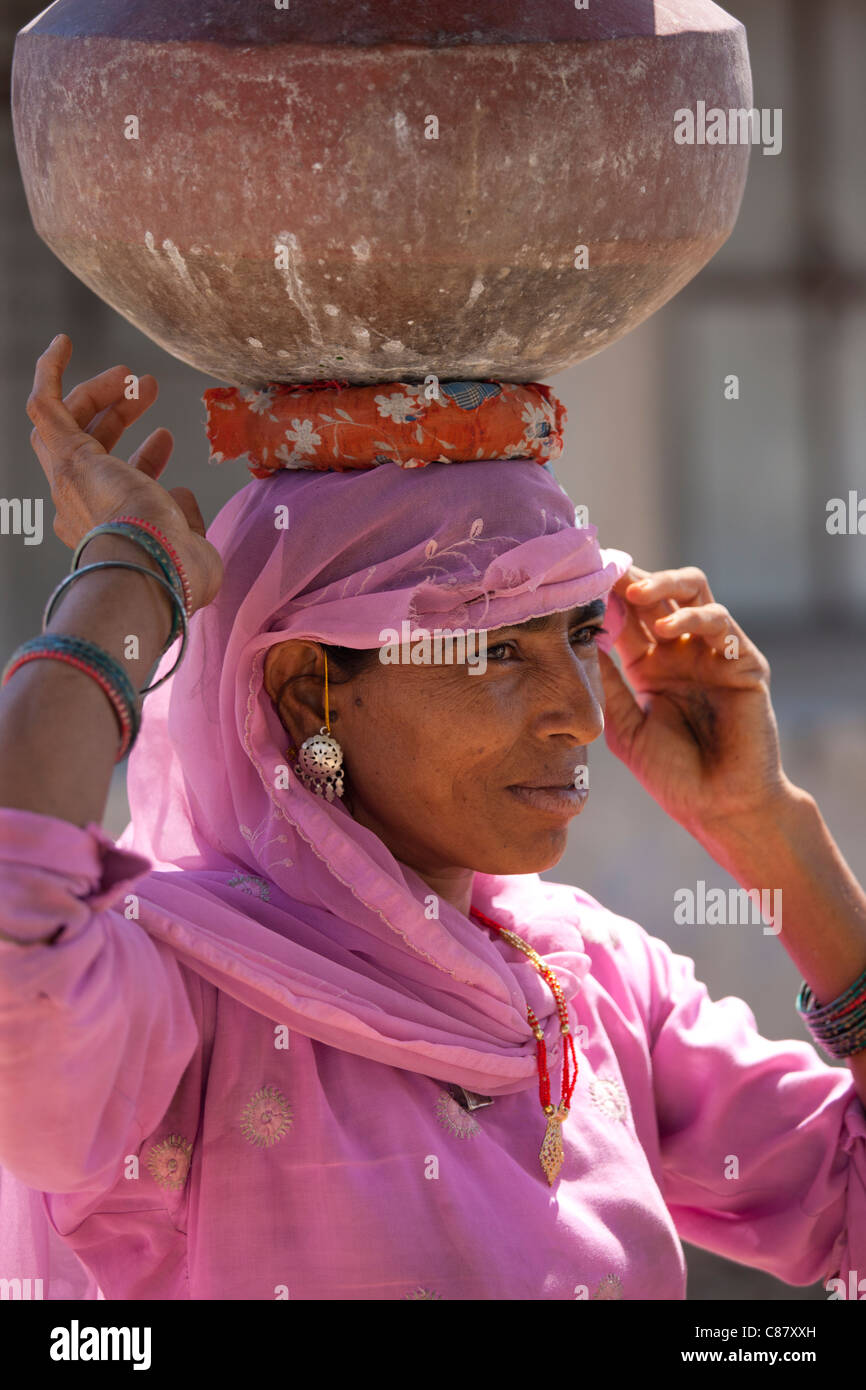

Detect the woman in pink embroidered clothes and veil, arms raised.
[{"left": 0, "top": 336, "right": 866, "bottom": 1300}]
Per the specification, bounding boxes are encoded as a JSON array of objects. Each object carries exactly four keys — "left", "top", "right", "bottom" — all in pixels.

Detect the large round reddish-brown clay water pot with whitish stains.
[{"left": 13, "top": 0, "right": 752, "bottom": 385}]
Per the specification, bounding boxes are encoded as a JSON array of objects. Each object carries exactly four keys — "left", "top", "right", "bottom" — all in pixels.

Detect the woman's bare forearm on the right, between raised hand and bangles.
[{"left": 695, "top": 787, "right": 866, "bottom": 1105}]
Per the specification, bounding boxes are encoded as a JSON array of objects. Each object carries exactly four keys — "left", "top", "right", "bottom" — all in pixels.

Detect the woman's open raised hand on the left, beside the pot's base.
[{"left": 26, "top": 334, "right": 222, "bottom": 612}]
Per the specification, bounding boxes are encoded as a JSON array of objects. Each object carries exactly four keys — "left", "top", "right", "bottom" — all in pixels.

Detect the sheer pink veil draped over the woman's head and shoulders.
[{"left": 118, "top": 459, "right": 631, "bottom": 1095}]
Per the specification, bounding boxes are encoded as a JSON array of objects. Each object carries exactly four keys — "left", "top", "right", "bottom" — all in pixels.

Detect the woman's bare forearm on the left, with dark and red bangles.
[{"left": 0, "top": 535, "right": 171, "bottom": 828}]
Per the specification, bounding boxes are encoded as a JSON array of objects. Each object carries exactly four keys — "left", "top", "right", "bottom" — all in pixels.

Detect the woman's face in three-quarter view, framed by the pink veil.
[{"left": 265, "top": 600, "right": 605, "bottom": 877}]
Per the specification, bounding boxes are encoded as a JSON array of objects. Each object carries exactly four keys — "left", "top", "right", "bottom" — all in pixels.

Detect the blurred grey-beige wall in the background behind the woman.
[{"left": 0, "top": 0, "right": 866, "bottom": 1300}]
